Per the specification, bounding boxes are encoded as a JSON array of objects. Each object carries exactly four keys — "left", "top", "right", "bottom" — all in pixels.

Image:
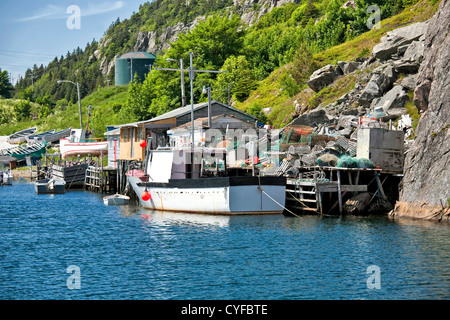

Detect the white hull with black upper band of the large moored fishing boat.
[{"left": 128, "top": 176, "right": 286, "bottom": 215}]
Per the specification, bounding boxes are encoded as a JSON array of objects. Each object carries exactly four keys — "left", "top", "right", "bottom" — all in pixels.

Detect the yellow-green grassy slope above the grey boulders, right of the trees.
[{"left": 236, "top": 1, "right": 439, "bottom": 127}]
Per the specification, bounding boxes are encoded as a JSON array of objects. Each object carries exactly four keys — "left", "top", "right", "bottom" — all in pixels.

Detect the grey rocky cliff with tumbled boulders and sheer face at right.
[{"left": 278, "top": 0, "right": 450, "bottom": 221}]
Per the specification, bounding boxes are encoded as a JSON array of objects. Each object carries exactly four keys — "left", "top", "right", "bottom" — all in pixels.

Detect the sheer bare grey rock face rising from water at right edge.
[{"left": 393, "top": 0, "right": 450, "bottom": 219}]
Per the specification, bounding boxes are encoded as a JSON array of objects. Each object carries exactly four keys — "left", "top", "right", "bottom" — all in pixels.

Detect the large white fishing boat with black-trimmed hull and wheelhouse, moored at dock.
[{"left": 127, "top": 149, "right": 286, "bottom": 215}]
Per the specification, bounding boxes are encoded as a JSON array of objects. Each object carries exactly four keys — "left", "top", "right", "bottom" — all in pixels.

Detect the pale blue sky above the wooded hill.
[{"left": 0, "top": 0, "right": 147, "bottom": 81}]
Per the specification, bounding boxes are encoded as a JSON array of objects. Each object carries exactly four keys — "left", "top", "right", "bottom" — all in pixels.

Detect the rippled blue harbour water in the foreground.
[{"left": 0, "top": 181, "right": 450, "bottom": 300}]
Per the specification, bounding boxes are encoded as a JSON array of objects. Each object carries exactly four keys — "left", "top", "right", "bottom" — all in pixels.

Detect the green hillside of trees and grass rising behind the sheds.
[{"left": 0, "top": 0, "right": 439, "bottom": 135}]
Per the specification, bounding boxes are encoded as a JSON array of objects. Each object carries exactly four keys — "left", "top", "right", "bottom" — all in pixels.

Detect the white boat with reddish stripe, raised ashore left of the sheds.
[{"left": 59, "top": 129, "right": 108, "bottom": 159}]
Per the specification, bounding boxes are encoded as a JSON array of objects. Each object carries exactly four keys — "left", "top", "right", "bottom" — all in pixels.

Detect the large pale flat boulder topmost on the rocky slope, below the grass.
[{"left": 372, "top": 21, "right": 429, "bottom": 60}]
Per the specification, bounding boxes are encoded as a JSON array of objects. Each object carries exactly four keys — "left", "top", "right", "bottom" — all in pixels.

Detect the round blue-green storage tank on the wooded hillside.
[{"left": 115, "top": 52, "right": 156, "bottom": 86}]
